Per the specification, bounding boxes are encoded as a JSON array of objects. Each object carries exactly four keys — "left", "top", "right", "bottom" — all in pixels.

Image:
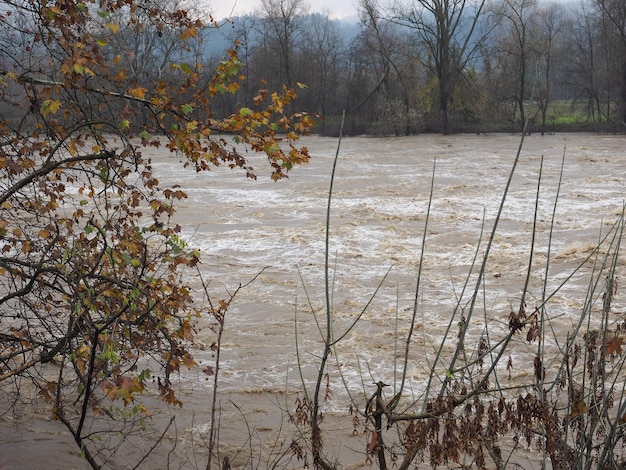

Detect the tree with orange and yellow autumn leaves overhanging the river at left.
[{"left": 0, "top": 0, "right": 312, "bottom": 468}]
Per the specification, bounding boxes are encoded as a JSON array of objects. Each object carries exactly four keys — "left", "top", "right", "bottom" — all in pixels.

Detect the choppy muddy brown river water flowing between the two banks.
[{"left": 0, "top": 134, "right": 626, "bottom": 468}]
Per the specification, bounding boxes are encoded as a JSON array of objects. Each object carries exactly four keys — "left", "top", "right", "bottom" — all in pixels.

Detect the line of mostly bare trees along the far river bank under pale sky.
[{"left": 0, "top": 0, "right": 626, "bottom": 135}]
